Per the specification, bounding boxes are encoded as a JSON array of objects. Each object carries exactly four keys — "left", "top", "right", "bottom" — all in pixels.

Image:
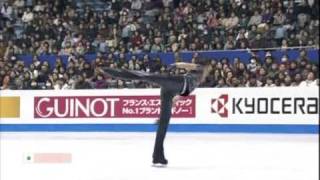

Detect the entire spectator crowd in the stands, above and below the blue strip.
[{"left": 0, "top": 0, "right": 319, "bottom": 90}]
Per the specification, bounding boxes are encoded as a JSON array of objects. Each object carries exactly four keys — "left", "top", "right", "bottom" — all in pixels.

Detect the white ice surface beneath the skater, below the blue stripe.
[{"left": 0, "top": 132, "right": 319, "bottom": 180}]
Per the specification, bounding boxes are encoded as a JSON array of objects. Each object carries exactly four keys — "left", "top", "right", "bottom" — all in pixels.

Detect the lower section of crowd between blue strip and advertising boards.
[{"left": 0, "top": 50, "right": 319, "bottom": 90}]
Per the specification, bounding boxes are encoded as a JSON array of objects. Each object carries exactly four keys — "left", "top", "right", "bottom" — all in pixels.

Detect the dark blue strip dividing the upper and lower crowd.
[{"left": 18, "top": 48, "right": 319, "bottom": 67}]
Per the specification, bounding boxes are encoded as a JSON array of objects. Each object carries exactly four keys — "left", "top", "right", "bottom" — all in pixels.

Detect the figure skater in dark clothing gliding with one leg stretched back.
[{"left": 101, "top": 62, "right": 211, "bottom": 165}]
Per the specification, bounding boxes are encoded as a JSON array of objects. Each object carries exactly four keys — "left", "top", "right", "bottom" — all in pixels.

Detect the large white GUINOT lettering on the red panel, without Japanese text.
[{"left": 34, "top": 97, "right": 119, "bottom": 118}]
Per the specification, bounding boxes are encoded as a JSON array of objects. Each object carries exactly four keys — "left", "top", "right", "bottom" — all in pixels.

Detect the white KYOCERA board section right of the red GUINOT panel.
[{"left": 197, "top": 87, "right": 319, "bottom": 124}]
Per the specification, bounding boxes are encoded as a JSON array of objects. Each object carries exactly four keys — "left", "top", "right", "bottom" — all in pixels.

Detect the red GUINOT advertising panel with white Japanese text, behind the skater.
[{"left": 34, "top": 96, "right": 196, "bottom": 118}]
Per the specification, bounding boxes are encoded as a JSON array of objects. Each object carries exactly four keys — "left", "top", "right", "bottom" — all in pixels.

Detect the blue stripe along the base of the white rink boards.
[{"left": 0, "top": 124, "right": 319, "bottom": 134}]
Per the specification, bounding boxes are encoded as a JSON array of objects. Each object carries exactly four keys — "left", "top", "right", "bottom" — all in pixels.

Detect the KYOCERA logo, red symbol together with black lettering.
[{"left": 211, "top": 94, "right": 319, "bottom": 118}]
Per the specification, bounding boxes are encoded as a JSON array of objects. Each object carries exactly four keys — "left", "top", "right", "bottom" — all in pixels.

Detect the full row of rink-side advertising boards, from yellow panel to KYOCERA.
[{"left": 0, "top": 87, "right": 320, "bottom": 131}]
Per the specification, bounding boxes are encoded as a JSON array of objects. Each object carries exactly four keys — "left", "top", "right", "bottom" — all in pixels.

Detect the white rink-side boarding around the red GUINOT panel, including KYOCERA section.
[{"left": 0, "top": 87, "right": 319, "bottom": 125}]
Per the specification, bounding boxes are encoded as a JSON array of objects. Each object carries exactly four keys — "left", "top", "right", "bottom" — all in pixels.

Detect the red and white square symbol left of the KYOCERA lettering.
[{"left": 211, "top": 94, "right": 228, "bottom": 118}]
